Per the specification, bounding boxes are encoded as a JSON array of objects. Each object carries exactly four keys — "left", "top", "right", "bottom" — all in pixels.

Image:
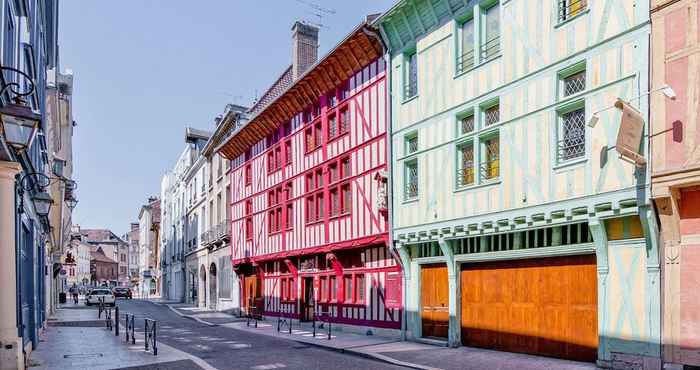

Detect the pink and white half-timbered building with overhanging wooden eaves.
[{"left": 219, "top": 18, "right": 402, "bottom": 329}]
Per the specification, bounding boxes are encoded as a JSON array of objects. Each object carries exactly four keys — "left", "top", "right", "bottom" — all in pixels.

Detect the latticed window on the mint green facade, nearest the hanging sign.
[{"left": 557, "top": 101, "right": 586, "bottom": 163}]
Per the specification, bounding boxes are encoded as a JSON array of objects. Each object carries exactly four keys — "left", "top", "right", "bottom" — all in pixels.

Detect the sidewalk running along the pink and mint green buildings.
[{"left": 160, "top": 303, "right": 596, "bottom": 370}]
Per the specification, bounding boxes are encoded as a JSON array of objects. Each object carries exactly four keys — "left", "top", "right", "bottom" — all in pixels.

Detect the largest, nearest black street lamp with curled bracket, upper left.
[{"left": 0, "top": 66, "right": 41, "bottom": 152}]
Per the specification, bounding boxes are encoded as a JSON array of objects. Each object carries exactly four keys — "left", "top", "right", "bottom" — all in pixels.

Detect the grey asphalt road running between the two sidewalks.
[{"left": 118, "top": 299, "right": 403, "bottom": 370}]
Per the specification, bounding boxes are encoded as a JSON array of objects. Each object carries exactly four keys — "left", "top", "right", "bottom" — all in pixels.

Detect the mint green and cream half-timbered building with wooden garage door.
[{"left": 377, "top": 0, "right": 660, "bottom": 367}]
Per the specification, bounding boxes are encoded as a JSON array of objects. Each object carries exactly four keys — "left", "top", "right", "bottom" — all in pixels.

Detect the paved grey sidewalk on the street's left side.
[{"left": 29, "top": 302, "right": 209, "bottom": 370}]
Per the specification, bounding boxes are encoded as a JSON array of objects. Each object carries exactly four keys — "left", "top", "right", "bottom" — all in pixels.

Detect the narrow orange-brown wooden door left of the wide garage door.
[{"left": 421, "top": 264, "right": 450, "bottom": 338}]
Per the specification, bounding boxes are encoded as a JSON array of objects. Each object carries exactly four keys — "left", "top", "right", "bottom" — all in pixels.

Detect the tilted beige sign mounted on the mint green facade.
[{"left": 615, "top": 99, "right": 647, "bottom": 166}]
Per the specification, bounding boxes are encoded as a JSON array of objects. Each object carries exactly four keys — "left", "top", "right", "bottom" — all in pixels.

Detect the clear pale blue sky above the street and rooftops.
[{"left": 59, "top": 0, "right": 394, "bottom": 235}]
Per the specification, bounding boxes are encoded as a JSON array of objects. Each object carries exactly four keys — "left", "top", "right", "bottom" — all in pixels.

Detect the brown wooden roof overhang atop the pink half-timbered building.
[{"left": 214, "top": 17, "right": 384, "bottom": 159}]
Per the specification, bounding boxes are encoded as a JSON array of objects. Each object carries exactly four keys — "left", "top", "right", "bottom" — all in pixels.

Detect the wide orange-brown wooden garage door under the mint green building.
[{"left": 461, "top": 255, "right": 598, "bottom": 361}]
